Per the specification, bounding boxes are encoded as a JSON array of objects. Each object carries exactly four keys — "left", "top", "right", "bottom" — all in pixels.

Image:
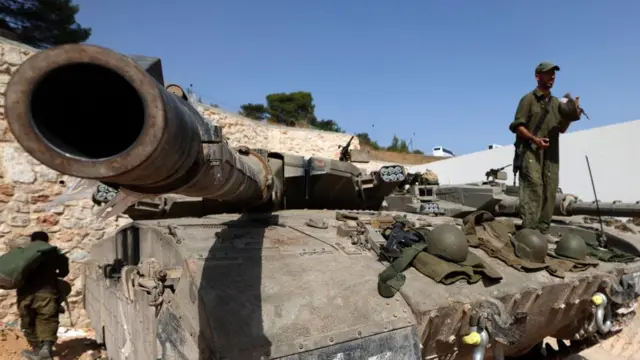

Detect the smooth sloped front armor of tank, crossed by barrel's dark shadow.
[{"left": 87, "top": 211, "right": 420, "bottom": 360}]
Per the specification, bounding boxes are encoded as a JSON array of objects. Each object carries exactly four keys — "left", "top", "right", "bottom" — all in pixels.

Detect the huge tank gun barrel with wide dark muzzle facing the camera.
[{"left": 6, "top": 44, "right": 273, "bottom": 205}]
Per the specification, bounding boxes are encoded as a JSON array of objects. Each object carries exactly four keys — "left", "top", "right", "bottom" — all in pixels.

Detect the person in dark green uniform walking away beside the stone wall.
[{"left": 17, "top": 231, "right": 69, "bottom": 359}]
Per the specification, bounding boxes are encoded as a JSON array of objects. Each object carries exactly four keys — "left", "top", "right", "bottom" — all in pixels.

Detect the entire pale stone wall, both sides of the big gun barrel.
[{"left": 0, "top": 38, "right": 396, "bottom": 326}]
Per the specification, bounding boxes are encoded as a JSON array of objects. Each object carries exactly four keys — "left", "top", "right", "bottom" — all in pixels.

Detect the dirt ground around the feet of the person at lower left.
[{"left": 0, "top": 327, "right": 106, "bottom": 360}]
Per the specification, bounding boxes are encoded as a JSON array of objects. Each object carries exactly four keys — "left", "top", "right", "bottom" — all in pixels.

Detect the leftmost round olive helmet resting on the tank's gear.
[{"left": 427, "top": 224, "right": 469, "bottom": 263}]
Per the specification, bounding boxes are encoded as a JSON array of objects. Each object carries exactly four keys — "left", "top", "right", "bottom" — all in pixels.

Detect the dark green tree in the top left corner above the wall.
[{"left": 0, "top": 0, "right": 91, "bottom": 49}]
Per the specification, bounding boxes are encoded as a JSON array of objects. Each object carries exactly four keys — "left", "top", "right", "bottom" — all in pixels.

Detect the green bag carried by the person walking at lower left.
[{"left": 0, "top": 241, "right": 59, "bottom": 290}]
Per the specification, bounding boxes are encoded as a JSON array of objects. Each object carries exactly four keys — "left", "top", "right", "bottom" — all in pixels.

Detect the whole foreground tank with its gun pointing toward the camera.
[{"left": 6, "top": 45, "right": 640, "bottom": 360}]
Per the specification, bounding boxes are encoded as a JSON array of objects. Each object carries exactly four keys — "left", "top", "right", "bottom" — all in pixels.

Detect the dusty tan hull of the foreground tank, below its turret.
[{"left": 85, "top": 210, "right": 640, "bottom": 360}]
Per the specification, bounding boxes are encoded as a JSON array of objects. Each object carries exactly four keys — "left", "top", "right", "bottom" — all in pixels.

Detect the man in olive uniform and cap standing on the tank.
[{"left": 509, "top": 62, "right": 582, "bottom": 242}]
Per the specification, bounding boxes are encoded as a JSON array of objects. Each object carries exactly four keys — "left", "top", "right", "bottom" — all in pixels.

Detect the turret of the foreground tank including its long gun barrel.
[{"left": 6, "top": 44, "right": 406, "bottom": 216}]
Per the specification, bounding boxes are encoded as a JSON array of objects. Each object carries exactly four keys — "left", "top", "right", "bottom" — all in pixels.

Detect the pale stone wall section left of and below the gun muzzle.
[{"left": 0, "top": 40, "right": 133, "bottom": 326}]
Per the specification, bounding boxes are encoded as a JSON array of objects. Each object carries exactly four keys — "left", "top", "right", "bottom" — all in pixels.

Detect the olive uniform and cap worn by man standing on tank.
[{"left": 509, "top": 63, "right": 566, "bottom": 234}]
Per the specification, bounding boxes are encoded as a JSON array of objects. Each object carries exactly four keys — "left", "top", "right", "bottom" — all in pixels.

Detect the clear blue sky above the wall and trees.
[{"left": 74, "top": 0, "right": 640, "bottom": 154}]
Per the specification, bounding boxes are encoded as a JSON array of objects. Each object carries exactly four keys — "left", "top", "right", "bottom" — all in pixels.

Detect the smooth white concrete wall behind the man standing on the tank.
[{"left": 409, "top": 118, "right": 640, "bottom": 202}]
